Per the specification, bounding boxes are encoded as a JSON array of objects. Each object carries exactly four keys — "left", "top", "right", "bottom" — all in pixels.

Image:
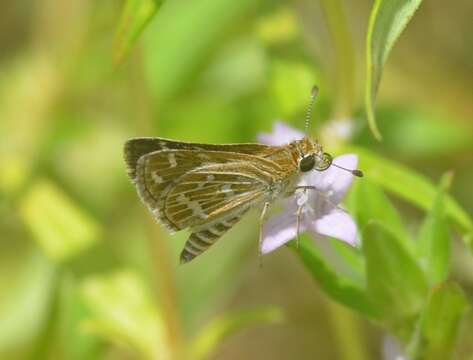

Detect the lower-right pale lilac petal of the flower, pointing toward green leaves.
[{"left": 309, "top": 208, "right": 359, "bottom": 246}]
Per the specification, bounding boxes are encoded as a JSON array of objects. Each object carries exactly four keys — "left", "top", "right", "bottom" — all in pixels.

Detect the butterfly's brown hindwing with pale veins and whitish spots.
[{"left": 134, "top": 150, "right": 280, "bottom": 235}]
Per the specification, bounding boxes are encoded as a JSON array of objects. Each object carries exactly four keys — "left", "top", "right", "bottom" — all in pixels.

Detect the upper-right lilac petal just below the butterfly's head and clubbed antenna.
[{"left": 303, "top": 154, "right": 358, "bottom": 204}]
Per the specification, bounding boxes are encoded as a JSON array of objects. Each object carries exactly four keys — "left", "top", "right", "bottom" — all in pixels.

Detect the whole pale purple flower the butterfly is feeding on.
[{"left": 258, "top": 122, "right": 358, "bottom": 254}]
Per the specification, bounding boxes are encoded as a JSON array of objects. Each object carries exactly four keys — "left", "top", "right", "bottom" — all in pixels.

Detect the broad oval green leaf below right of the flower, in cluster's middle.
[{"left": 363, "top": 222, "right": 428, "bottom": 338}]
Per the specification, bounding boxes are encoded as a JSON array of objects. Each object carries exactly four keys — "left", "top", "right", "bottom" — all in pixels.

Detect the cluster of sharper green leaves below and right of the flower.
[{"left": 300, "top": 174, "right": 466, "bottom": 359}]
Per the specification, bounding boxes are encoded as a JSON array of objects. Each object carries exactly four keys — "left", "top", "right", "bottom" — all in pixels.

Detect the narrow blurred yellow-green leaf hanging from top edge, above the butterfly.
[{"left": 114, "top": 0, "right": 164, "bottom": 64}]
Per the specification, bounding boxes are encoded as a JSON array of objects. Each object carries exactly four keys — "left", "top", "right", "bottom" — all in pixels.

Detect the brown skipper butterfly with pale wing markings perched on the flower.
[{"left": 124, "top": 86, "right": 362, "bottom": 263}]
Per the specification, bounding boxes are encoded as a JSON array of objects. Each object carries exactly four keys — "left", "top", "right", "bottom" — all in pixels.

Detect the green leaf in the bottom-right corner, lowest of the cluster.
[{"left": 409, "top": 283, "right": 468, "bottom": 360}]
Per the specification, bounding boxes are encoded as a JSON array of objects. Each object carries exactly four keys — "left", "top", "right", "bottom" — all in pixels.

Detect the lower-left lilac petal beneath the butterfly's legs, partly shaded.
[{"left": 261, "top": 212, "right": 306, "bottom": 254}]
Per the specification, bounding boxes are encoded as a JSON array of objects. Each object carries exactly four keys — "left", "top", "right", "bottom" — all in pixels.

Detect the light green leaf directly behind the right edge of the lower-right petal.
[{"left": 347, "top": 177, "right": 413, "bottom": 250}]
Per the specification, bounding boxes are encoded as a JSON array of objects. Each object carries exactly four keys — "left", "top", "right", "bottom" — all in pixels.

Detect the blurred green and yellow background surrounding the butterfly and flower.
[{"left": 0, "top": 0, "right": 473, "bottom": 360}]
